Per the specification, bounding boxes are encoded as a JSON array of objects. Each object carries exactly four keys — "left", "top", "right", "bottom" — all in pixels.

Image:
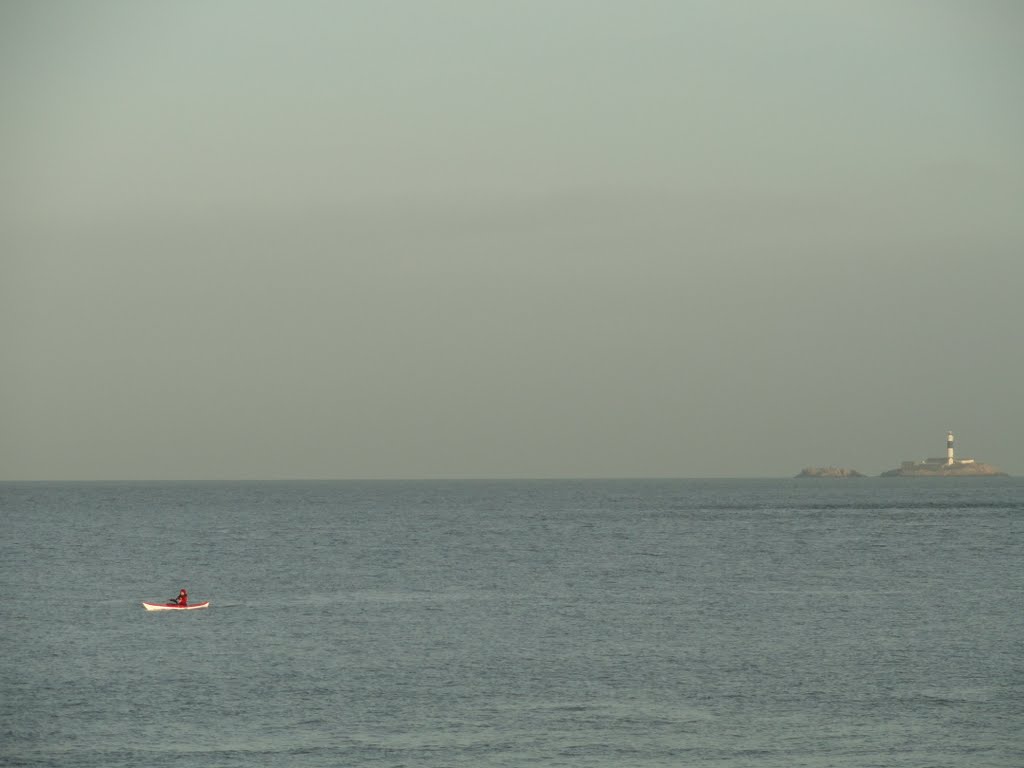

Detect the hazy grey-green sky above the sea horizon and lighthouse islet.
[{"left": 0, "top": 0, "right": 1024, "bottom": 480}]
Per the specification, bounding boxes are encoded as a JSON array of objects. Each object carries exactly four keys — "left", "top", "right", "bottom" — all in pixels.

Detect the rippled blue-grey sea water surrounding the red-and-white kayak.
[{"left": 0, "top": 478, "right": 1024, "bottom": 768}]
